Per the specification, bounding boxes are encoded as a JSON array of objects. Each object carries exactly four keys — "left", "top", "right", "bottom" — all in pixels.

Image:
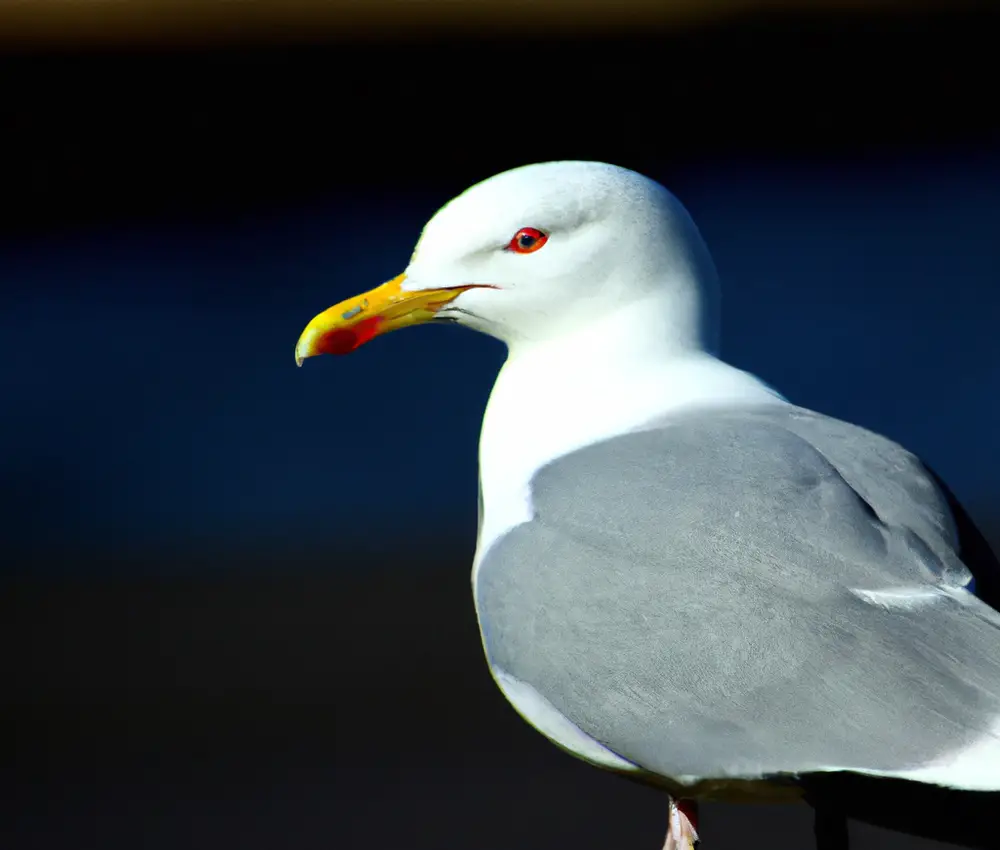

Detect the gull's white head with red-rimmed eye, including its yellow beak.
[{"left": 296, "top": 162, "right": 718, "bottom": 362}]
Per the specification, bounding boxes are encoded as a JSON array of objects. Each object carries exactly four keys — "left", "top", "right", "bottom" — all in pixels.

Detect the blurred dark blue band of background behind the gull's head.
[{"left": 0, "top": 153, "right": 1000, "bottom": 572}]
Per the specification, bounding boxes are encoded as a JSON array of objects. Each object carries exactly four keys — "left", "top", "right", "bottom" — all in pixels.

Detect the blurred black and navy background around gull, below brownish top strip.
[{"left": 0, "top": 3, "right": 1000, "bottom": 850}]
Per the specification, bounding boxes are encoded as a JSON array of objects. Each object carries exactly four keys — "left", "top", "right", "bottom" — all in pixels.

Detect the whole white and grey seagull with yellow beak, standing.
[{"left": 295, "top": 162, "right": 1000, "bottom": 850}]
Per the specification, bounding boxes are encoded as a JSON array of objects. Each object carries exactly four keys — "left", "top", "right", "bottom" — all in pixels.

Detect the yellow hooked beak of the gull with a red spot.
[{"left": 295, "top": 274, "right": 474, "bottom": 366}]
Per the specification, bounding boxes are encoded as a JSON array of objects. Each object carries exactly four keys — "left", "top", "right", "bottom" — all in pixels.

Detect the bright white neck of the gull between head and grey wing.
[{"left": 476, "top": 304, "right": 782, "bottom": 568}]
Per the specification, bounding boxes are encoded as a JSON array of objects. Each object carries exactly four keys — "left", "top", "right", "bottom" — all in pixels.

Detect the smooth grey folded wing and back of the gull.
[{"left": 477, "top": 406, "right": 1000, "bottom": 778}]
